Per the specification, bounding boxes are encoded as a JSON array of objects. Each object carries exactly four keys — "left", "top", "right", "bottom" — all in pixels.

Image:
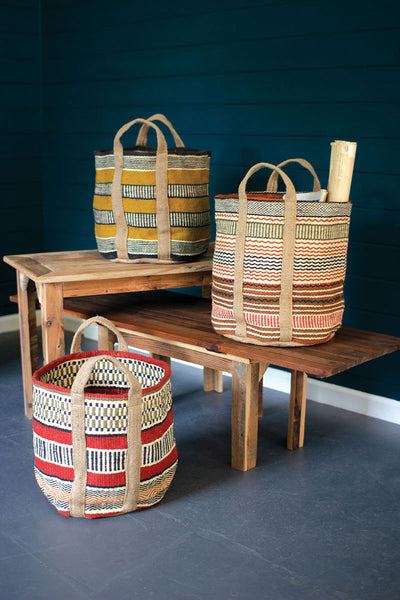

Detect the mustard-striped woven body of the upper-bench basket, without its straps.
[{"left": 93, "top": 146, "right": 211, "bottom": 260}]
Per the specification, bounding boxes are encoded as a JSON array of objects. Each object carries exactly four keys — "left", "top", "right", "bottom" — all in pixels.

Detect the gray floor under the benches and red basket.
[{"left": 0, "top": 334, "right": 400, "bottom": 600}]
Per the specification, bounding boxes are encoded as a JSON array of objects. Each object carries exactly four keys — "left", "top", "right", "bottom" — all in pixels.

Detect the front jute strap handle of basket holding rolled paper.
[{"left": 233, "top": 163, "right": 297, "bottom": 342}]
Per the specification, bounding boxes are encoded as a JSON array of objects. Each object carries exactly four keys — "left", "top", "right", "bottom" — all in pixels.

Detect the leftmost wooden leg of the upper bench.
[{"left": 17, "top": 271, "right": 39, "bottom": 419}]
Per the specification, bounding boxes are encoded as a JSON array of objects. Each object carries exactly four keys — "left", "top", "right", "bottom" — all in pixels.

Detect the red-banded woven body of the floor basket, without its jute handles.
[{"left": 33, "top": 351, "right": 177, "bottom": 518}]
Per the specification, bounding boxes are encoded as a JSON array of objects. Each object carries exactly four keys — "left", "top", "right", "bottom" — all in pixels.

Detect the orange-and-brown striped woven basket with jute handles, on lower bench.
[{"left": 212, "top": 159, "right": 351, "bottom": 346}]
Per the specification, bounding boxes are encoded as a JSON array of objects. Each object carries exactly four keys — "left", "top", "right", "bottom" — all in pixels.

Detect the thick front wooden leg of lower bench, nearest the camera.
[{"left": 232, "top": 361, "right": 260, "bottom": 471}]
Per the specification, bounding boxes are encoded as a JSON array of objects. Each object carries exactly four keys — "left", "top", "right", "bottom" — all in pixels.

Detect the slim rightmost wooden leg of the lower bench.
[{"left": 287, "top": 371, "right": 307, "bottom": 450}]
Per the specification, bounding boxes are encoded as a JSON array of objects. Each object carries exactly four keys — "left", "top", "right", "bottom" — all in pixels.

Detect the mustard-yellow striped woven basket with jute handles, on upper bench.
[{"left": 93, "top": 114, "right": 211, "bottom": 264}]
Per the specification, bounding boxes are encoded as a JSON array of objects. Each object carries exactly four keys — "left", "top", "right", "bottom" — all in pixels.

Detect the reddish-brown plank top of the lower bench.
[{"left": 64, "top": 291, "right": 400, "bottom": 379}]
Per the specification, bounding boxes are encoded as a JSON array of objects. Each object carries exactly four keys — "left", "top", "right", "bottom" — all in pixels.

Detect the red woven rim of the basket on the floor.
[{"left": 32, "top": 350, "right": 171, "bottom": 400}]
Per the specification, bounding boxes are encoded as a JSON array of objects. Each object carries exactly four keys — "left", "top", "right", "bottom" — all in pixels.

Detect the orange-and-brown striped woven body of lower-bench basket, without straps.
[{"left": 212, "top": 192, "right": 351, "bottom": 346}]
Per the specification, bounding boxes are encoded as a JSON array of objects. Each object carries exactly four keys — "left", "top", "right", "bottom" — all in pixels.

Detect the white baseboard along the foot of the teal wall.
[{"left": 0, "top": 311, "right": 400, "bottom": 425}]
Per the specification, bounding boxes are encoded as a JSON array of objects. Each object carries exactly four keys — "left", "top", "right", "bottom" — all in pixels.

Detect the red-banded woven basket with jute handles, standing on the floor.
[{"left": 33, "top": 317, "right": 177, "bottom": 518}]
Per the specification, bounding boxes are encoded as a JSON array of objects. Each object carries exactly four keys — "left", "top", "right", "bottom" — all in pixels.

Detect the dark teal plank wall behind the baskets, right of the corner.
[{"left": 4, "top": 0, "right": 400, "bottom": 399}]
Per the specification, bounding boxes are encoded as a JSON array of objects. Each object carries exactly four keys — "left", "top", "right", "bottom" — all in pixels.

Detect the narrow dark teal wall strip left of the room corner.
[{"left": 0, "top": 0, "right": 43, "bottom": 315}]
